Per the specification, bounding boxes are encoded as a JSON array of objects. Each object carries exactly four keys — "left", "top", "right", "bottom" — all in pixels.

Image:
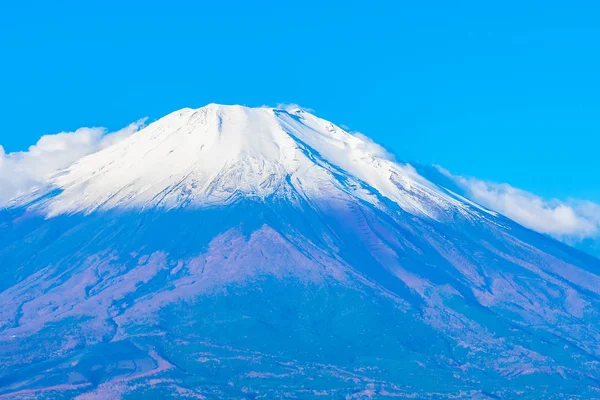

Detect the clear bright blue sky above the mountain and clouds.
[{"left": 0, "top": 0, "right": 600, "bottom": 202}]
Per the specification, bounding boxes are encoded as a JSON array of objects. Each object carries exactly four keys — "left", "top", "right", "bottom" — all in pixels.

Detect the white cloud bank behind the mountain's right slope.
[{"left": 438, "top": 167, "right": 600, "bottom": 244}]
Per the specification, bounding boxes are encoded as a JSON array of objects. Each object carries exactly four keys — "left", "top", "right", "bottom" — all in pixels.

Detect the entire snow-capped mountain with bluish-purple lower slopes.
[{"left": 0, "top": 104, "right": 600, "bottom": 399}]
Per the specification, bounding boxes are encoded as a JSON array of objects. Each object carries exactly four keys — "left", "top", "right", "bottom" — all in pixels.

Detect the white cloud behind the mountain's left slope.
[{"left": 0, "top": 118, "right": 146, "bottom": 205}]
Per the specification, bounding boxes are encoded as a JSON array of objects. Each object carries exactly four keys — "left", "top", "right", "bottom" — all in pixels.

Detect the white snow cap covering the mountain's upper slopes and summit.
[{"left": 29, "top": 104, "right": 463, "bottom": 217}]
